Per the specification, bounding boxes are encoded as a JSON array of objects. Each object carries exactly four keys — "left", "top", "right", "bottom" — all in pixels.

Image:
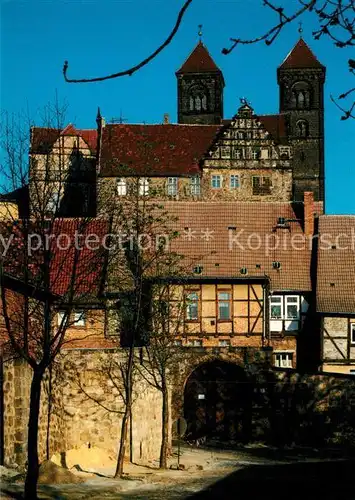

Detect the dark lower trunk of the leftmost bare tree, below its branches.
[{"left": 25, "top": 370, "right": 43, "bottom": 500}]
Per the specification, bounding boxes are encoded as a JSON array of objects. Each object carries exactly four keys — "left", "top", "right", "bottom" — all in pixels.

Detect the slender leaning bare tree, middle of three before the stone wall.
[{"left": 93, "top": 175, "right": 185, "bottom": 477}]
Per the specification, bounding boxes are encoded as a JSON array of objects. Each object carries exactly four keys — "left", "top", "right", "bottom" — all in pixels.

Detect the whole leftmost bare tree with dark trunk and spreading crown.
[{"left": 0, "top": 103, "right": 107, "bottom": 499}]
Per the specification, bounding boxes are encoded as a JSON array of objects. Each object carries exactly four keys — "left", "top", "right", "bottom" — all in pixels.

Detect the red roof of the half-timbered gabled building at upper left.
[{"left": 31, "top": 123, "right": 97, "bottom": 154}]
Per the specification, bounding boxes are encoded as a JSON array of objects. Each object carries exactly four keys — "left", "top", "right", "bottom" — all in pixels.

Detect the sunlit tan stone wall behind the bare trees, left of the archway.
[{"left": 4, "top": 350, "right": 161, "bottom": 465}]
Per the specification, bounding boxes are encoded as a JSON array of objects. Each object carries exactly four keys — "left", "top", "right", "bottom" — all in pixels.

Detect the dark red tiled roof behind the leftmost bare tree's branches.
[{"left": 2, "top": 219, "right": 108, "bottom": 300}]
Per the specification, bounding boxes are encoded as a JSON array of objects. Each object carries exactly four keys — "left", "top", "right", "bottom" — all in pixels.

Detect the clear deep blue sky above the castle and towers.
[{"left": 0, "top": 0, "right": 355, "bottom": 214}]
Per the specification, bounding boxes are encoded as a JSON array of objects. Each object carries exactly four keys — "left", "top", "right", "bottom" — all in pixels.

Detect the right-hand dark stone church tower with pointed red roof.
[{"left": 277, "top": 38, "right": 325, "bottom": 201}]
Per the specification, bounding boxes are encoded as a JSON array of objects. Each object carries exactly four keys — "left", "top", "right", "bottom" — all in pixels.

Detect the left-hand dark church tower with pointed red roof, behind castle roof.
[{"left": 176, "top": 40, "right": 224, "bottom": 125}]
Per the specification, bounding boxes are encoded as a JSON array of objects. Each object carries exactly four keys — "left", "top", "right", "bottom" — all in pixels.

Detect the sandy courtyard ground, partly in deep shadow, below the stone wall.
[{"left": 0, "top": 446, "right": 355, "bottom": 500}]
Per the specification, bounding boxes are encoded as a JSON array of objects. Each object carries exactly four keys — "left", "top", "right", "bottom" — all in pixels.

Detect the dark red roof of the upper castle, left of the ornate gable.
[{"left": 100, "top": 124, "right": 219, "bottom": 176}]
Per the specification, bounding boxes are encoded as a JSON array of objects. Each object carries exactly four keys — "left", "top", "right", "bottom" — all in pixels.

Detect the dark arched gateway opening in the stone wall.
[{"left": 184, "top": 360, "right": 252, "bottom": 443}]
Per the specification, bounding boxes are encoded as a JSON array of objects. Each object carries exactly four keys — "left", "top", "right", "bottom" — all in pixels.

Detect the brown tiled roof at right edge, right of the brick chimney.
[{"left": 317, "top": 215, "right": 355, "bottom": 314}]
